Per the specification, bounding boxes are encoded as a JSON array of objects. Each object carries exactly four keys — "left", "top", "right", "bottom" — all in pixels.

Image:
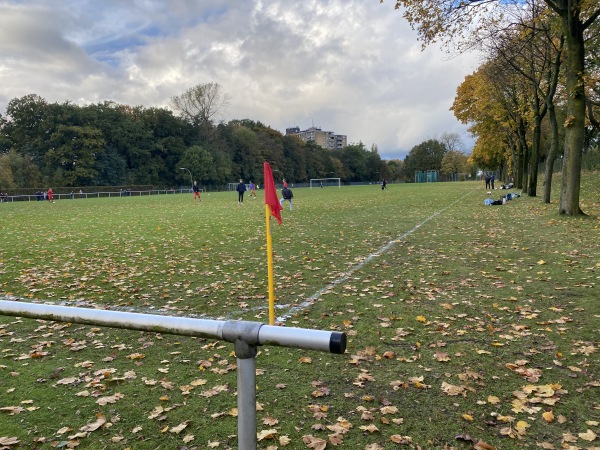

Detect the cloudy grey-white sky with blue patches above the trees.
[{"left": 0, "top": 0, "right": 477, "bottom": 159}]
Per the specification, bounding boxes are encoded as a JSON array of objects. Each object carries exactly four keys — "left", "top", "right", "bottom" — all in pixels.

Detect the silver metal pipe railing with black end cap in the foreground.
[{"left": 0, "top": 300, "right": 346, "bottom": 450}]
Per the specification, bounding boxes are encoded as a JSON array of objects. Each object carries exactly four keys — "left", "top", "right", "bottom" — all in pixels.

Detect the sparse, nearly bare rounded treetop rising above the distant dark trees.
[{"left": 171, "top": 83, "right": 230, "bottom": 127}]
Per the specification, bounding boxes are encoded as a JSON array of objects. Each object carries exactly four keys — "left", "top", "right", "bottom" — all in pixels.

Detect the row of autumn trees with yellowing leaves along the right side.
[{"left": 390, "top": 0, "right": 600, "bottom": 215}]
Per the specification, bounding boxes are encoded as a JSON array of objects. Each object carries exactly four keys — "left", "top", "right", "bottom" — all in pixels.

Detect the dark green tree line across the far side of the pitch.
[{"left": 0, "top": 88, "right": 466, "bottom": 192}]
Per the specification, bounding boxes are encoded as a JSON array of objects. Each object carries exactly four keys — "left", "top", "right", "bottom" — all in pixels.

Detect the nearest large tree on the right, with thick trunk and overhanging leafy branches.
[{"left": 396, "top": 0, "right": 600, "bottom": 215}]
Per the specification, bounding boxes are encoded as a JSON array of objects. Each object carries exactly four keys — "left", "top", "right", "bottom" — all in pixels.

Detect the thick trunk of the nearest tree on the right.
[{"left": 558, "top": 1, "right": 585, "bottom": 216}]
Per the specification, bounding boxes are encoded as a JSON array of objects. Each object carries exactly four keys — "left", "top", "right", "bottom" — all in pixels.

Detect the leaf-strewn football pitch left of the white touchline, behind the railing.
[{"left": 1, "top": 184, "right": 484, "bottom": 320}]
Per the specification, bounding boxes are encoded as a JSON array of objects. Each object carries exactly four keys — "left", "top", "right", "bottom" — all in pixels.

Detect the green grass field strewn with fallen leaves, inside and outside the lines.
[{"left": 0, "top": 177, "right": 600, "bottom": 450}]
